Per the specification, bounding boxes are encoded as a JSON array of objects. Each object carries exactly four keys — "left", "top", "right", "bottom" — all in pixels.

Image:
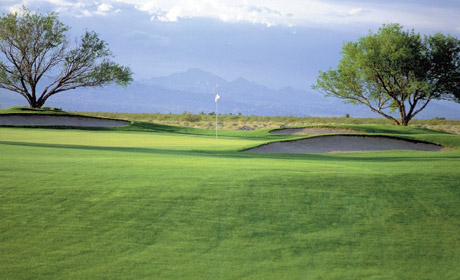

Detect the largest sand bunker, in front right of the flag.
[{"left": 246, "top": 135, "right": 451, "bottom": 154}]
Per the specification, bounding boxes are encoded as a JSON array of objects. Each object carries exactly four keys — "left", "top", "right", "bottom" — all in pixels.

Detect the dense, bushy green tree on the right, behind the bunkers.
[{"left": 313, "top": 24, "right": 460, "bottom": 126}]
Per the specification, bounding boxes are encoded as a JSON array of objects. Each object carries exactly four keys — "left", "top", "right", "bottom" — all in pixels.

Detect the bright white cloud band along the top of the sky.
[{"left": 0, "top": 0, "right": 460, "bottom": 32}]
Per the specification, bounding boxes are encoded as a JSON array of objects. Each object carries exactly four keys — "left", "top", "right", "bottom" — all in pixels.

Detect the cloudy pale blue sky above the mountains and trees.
[{"left": 0, "top": 0, "right": 460, "bottom": 89}]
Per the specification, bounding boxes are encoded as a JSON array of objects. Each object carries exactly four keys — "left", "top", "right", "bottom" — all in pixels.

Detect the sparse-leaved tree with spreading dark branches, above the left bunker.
[{"left": 0, "top": 7, "right": 132, "bottom": 108}]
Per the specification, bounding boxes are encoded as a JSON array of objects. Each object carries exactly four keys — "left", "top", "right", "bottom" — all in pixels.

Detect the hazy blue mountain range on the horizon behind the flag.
[{"left": 0, "top": 68, "right": 460, "bottom": 120}]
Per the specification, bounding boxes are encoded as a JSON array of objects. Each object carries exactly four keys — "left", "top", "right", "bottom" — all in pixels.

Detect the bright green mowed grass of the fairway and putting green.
[{"left": 0, "top": 124, "right": 460, "bottom": 279}]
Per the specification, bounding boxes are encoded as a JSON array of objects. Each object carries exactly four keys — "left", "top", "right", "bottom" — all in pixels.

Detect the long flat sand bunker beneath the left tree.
[{"left": 0, "top": 114, "right": 131, "bottom": 127}]
